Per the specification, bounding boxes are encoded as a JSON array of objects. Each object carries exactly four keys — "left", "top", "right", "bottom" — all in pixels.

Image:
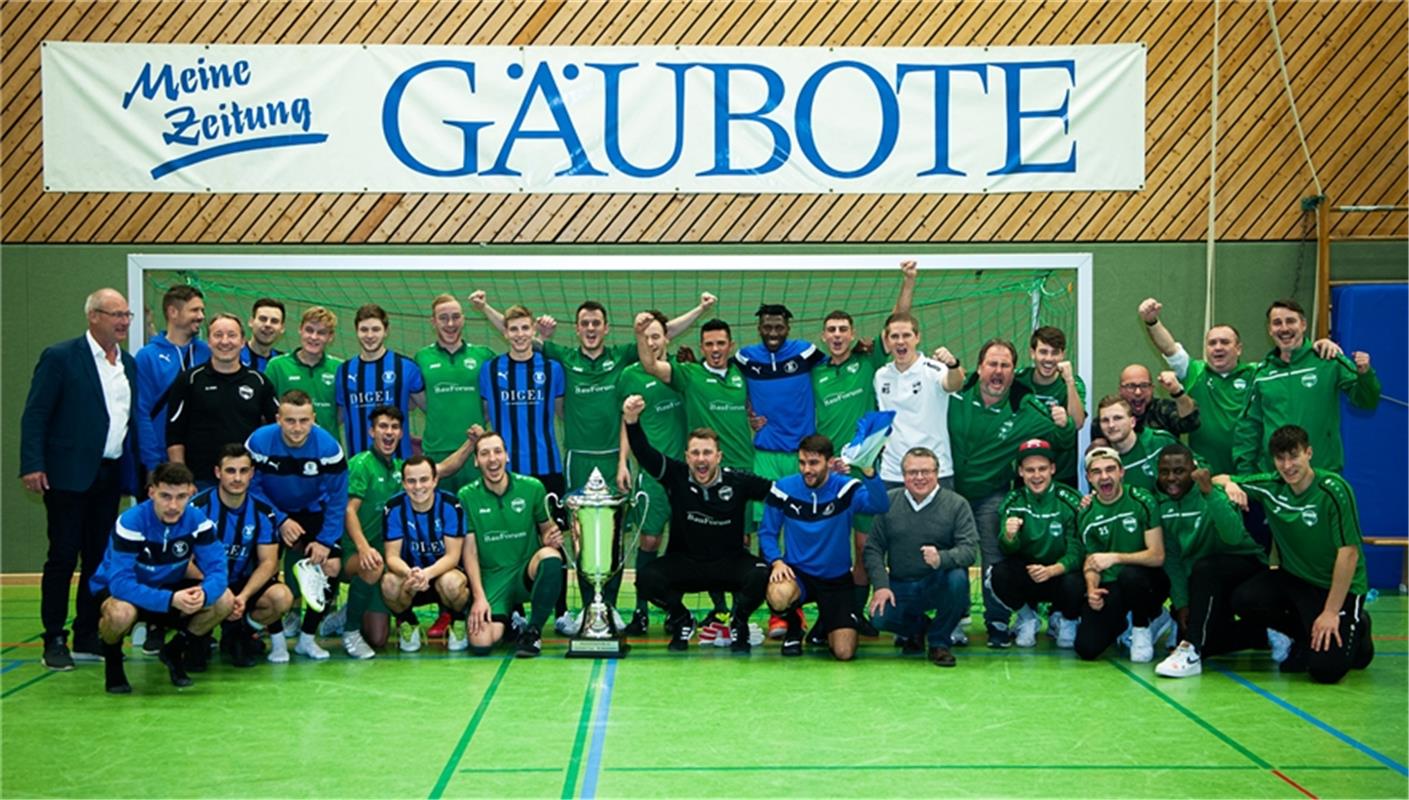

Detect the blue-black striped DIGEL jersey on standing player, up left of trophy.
[{"left": 479, "top": 352, "right": 566, "bottom": 476}]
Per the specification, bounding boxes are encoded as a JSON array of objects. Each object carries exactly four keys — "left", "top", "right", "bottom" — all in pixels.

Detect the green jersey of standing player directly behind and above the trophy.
[{"left": 542, "top": 342, "right": 637, "bottom": 454}]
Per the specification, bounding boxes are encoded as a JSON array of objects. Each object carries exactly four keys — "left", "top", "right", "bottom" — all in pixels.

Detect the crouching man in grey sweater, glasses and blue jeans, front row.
[{"left": 864, "top": 446, "right": 978, "bottom": 666}]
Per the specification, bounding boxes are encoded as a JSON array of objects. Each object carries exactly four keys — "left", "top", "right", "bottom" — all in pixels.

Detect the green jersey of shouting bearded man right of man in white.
[{"left": 948, "top": 383, "right": 1076, "bottom": 503}]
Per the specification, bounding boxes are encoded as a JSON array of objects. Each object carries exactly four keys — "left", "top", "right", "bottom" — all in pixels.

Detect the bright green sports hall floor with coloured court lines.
[{"left": 0, "top": 585, "right": 1409, "bottom": 797}]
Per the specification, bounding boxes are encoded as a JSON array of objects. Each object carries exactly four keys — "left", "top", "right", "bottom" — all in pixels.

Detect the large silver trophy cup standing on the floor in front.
[{"left": 545, "top": 469, "right": 651, "bottom": 658}]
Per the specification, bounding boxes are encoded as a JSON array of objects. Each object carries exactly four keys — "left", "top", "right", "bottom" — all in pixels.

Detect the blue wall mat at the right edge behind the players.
[{"left": 1332, "top": 283, "right": 1409, "bottom": 586}]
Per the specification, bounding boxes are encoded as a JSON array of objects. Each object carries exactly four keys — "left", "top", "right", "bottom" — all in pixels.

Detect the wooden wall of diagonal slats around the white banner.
[{"left": 0, "top": 0, "right": 1409, "bottom": 244}]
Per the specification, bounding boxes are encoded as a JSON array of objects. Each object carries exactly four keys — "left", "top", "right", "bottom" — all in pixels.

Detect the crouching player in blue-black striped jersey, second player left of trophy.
[{"left": 382, "top": 455, "right": 469, "bottom": 652}]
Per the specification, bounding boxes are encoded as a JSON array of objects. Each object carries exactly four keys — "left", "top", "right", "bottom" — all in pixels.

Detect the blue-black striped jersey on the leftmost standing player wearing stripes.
[{"left": 333, "top": 351, "right": 426, "bottom": 458}]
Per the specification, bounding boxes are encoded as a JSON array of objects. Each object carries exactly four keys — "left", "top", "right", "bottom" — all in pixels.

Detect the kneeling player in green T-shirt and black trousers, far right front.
[{"left": 1220, "top": 425, "right": 1375, "bottom": 683}]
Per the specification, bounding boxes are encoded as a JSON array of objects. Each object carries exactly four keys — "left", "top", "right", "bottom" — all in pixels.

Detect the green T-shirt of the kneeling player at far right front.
[{"left": 1233, "top": 469, "right": 1368, "bottom": 594}]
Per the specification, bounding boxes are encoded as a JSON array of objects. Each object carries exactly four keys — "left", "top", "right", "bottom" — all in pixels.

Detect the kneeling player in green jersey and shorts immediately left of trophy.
[{"left": 459, "top": 432, "right": 562, "bottom": 658}]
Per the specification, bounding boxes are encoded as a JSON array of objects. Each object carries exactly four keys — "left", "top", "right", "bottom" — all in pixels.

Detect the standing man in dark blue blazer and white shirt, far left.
[{"left": 20, "top": 289, "right": 137, "bottom": 670}]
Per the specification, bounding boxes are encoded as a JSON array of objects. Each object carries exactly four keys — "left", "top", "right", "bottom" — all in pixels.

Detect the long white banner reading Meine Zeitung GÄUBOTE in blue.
[{"left": 42, "top": 42, "right": 1146, "bottom": 193}]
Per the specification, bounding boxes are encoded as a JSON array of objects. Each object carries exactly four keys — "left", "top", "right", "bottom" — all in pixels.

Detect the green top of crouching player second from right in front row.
[{"left": 1158, "top": 486, "right": 1267, "bottom": 608}]
